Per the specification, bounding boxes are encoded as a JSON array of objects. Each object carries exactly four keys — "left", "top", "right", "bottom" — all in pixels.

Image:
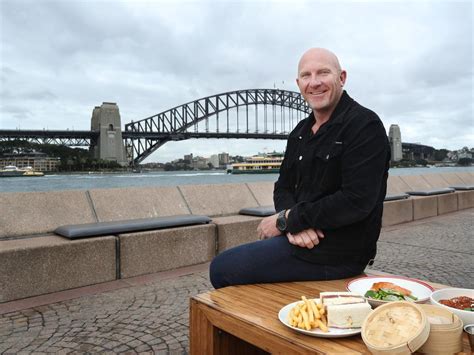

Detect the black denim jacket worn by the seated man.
[{"left": 273, "top": 91, "right": 390, "bottom": 264}]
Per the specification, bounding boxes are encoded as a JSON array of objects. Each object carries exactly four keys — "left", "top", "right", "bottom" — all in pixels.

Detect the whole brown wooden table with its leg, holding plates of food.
[{"left": 190, "top": 274, "right": 470, "bottom": 355}]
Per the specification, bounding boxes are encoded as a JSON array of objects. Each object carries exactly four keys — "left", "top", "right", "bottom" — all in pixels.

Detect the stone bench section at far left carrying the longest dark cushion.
[{"left": 0, "top": 187, "right": 216, "bottom": 302}]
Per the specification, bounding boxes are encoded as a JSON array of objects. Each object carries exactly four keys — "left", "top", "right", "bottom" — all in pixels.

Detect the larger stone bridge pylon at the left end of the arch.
[{"left": 90, "top": 102, "right": 128, "bottom": 166}]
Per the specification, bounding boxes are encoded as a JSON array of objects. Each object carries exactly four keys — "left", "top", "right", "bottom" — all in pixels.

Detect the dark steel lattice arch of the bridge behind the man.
[{"left": 123, "top": 89, "right": 311, "bottom": 164}]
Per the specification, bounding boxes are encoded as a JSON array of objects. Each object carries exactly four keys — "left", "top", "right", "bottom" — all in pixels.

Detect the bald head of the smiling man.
[{"left": 296, "top": 48, "right": 347, "bottom": 114}]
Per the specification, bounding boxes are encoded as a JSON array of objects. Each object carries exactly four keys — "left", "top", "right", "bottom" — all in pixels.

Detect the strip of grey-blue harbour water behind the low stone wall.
[{"left": 0, "top": 166, "right": 474, "bottom": 192}]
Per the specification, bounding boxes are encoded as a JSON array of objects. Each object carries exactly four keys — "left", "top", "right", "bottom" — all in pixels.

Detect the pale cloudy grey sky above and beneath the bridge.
[{"left": 0, "top": 0, "right": 474, "bottom": 163}]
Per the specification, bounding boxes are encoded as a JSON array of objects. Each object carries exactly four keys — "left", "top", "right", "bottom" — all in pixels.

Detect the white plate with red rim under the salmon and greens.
[{"left": 347, "top": 276, "right": 434, "bottom": 307}]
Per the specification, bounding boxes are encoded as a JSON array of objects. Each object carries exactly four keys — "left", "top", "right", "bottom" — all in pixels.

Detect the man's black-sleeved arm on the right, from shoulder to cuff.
[{"left": 288, "top": 120, "right": 388, "bottom": 234}]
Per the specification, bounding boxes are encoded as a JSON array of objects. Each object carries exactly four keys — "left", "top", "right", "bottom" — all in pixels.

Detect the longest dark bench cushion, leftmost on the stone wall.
[{"left": 54, "top": 215, "right": 211, "bottom": 239}]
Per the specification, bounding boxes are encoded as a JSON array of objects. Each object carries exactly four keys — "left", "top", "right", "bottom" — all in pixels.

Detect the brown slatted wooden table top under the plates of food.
[{"left": 193, "top": 273, "right": 469, "bottom": 354}]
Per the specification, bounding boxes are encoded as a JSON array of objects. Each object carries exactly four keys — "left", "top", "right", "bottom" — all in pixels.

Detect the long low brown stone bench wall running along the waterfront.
[{"left": 0, "top": 173, "right": 474, "bottom": 303}]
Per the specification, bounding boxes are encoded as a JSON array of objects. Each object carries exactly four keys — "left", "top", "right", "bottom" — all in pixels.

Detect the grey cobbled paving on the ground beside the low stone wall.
[{"left": 0, "top": 209, "right": 474, "bottom": 354}]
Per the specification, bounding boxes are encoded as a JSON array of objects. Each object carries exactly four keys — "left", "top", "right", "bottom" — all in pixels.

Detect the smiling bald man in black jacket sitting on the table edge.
[{"left": 210, "top": 48, "right": 390, "bottom": 288}]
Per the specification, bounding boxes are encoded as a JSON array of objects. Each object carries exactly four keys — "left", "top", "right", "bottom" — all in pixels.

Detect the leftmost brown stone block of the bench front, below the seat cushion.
[{"left": 0, "top": 236, "right": 116, "bottom": 303}]
